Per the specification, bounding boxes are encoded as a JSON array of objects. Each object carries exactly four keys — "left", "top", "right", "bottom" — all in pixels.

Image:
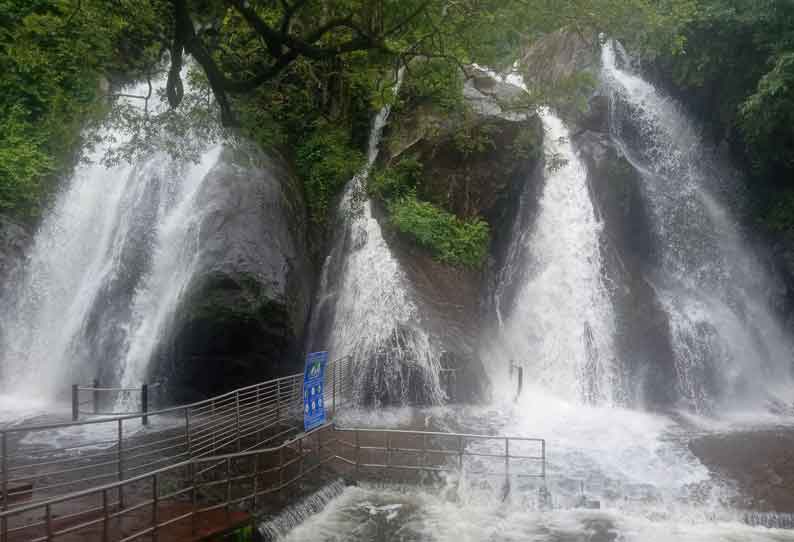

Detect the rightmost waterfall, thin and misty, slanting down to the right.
[{"left": 602, "top": 42, "right": 791, "bottom": 410}]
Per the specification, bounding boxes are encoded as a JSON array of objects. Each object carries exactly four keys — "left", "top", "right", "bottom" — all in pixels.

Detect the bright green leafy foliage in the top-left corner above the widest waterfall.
[{"left": 0, "top": 0, "right": 167, "bottom": 220}]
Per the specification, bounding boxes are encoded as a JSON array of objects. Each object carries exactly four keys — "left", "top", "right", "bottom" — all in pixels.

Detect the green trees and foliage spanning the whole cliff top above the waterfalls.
[{"left": 0, "top": 0, "right": 794, "bottom": 249}]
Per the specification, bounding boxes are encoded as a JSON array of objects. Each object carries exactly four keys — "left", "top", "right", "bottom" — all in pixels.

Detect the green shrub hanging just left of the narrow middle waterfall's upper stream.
[{"left": 295, "top": 123, "right": 364, "bottom": 226}]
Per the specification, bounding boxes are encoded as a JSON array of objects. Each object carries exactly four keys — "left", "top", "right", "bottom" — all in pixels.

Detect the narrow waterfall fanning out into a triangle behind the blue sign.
[{"left": 310, "top": 72, "right": 444, "bottom": 404}]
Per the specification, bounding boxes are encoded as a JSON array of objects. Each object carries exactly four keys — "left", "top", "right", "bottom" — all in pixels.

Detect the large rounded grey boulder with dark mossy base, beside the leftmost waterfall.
[{"left": 153, "top": 148, "right": 313, "bottom": 399}]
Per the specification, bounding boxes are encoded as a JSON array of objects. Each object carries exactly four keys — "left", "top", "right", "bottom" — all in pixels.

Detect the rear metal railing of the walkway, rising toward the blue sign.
[{"left": 0, "top": 358, "right": 352, "bottom": 510}]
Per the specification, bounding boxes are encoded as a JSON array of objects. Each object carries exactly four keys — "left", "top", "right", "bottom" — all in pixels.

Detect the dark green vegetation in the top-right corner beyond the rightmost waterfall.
[{"left": 645, "top": 0, "right": 794, "bottom": 231}]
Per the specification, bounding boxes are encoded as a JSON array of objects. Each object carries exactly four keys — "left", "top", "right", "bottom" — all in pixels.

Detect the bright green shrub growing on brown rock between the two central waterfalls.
[{"left": 389, "top": 198, "right": 490, "bottom": 268}]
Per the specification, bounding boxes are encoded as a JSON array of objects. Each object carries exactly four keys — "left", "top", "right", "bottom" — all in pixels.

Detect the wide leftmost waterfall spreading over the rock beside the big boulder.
[{"left": 0, "top": 76, "right": 220, "bottom": 408}]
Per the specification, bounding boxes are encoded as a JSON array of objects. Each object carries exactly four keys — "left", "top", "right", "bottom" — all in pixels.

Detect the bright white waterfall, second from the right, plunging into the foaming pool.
[{"left": 494, "top": 111, "right": 622, "bottom": 404}]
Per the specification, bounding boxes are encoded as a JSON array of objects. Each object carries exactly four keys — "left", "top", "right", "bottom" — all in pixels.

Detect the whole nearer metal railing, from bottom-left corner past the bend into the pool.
[{"left": 0, "top": 424, "right": 546, "bottom": 542}]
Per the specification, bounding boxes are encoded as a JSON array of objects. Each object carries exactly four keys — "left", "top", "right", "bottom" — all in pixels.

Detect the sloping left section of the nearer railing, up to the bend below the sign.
[{"left": 0, "top": 424, "right": 336, "bottom": 542}]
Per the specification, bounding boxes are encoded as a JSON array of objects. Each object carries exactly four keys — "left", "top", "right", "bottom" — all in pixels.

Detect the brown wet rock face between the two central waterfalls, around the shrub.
[{"left": 375, "top": 72, "right": 543, "bottom": 402}]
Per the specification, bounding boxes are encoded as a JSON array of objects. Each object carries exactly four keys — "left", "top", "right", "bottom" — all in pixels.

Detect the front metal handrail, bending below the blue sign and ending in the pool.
[{"left": 0, "top": 422, "right": 546, "bottom": 541}]
